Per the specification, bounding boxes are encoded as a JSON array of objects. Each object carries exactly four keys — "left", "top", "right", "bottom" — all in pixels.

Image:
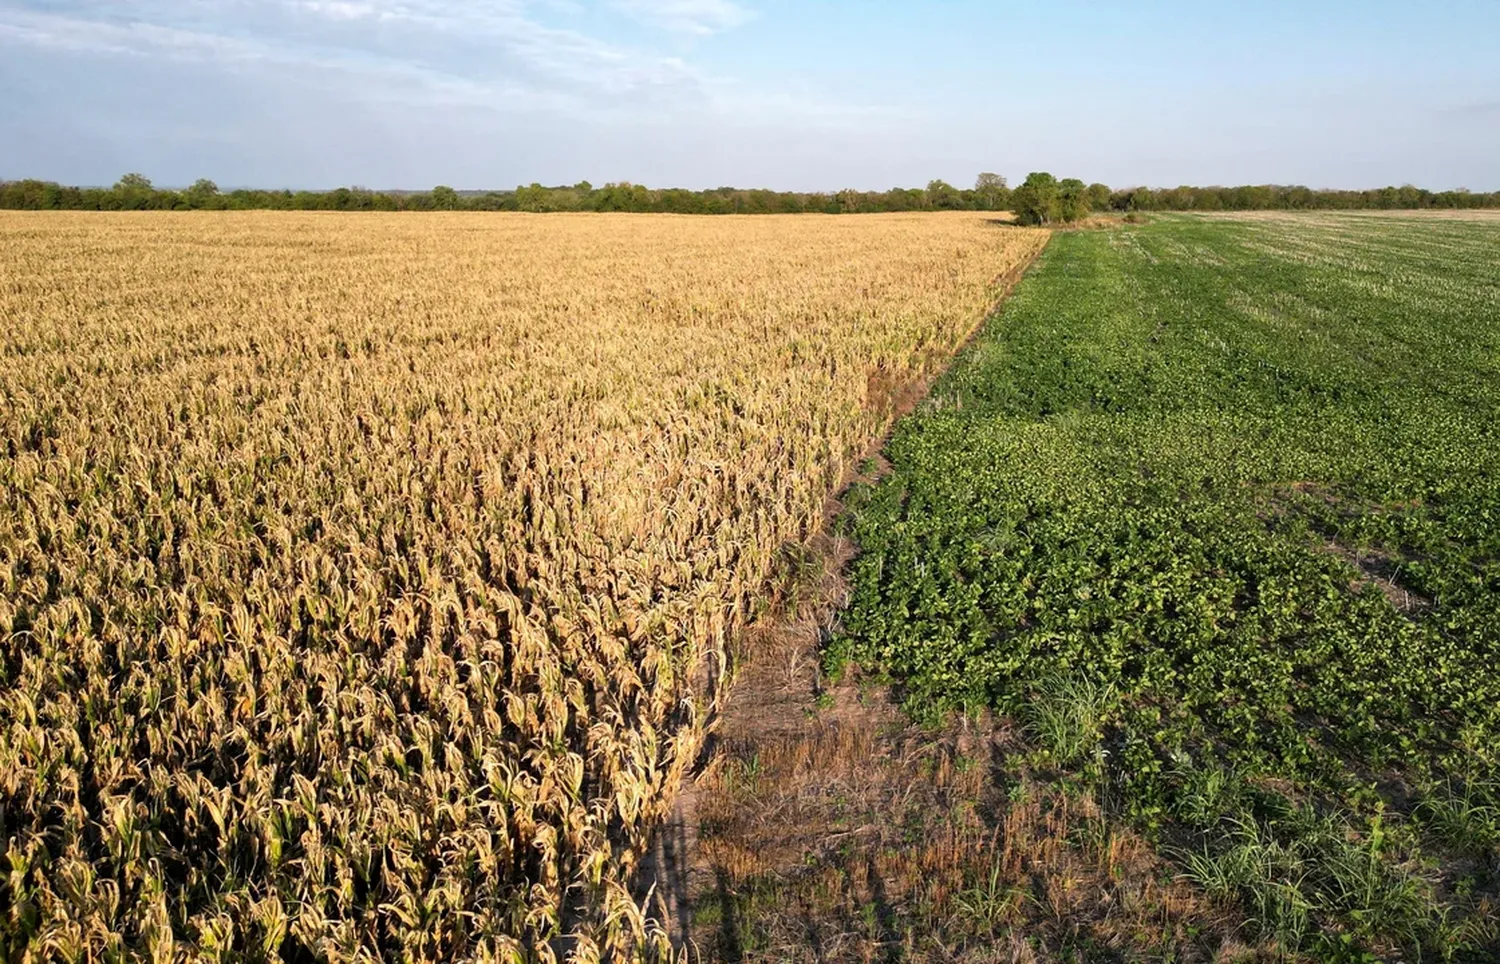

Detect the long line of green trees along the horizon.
[{"left": 0, "top": 172, "right": 1500, "bottom": 223}]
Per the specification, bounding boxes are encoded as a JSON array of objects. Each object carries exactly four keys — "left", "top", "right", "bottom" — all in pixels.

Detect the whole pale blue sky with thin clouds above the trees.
[{"left": 0, "top": 0, "right": 1500, "bottom": 190}]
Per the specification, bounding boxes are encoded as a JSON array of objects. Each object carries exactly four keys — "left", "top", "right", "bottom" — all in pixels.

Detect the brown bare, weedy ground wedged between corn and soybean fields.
[{"left": 642, "top": 250, "right": 1275, "bottom": 963}]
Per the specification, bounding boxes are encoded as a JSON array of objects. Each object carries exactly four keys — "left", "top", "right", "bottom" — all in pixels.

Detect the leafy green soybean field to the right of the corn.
[{"left": 825, "top": 214, "right": 1500, "bottom": 961}]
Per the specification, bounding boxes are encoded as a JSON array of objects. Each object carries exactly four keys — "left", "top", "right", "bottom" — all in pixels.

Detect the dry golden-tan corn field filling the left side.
[{"left": 0, "top": 213, "right": 1046, "bottom": 961}]
